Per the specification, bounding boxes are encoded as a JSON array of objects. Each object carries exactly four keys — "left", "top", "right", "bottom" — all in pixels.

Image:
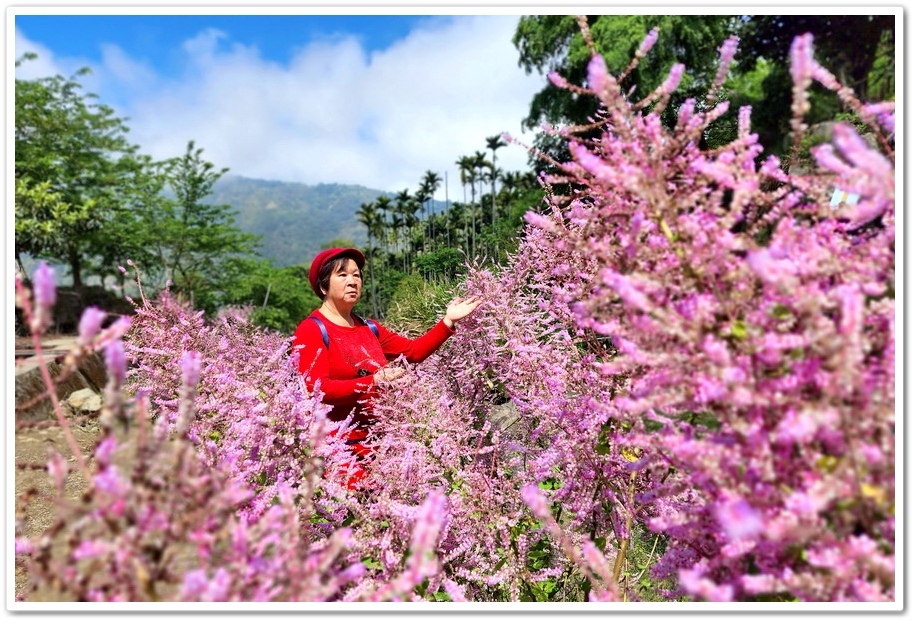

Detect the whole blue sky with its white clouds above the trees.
[{"left": 8, "top": 7, "right": 546, "bottom": 195}]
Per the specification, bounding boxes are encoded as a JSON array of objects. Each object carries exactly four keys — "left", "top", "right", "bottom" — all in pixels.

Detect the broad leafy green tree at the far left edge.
[{"left": 14, "top": 54, "right": 144, "bottom": 288}]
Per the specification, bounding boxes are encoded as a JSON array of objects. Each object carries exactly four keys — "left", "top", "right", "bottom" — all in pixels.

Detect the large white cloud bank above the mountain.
[{"left": 17, "top": 15, "right": 544, "bottom": 199}]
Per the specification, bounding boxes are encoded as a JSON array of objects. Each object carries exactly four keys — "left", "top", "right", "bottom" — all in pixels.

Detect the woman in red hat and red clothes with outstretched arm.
[{"left": 293, "top": 248, "right": 482, "bottom": 489}]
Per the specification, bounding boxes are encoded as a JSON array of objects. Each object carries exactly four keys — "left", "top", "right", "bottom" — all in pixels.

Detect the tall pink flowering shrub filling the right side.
[{"left": 500, "top": 30, "right": 895, "bottom": 601}]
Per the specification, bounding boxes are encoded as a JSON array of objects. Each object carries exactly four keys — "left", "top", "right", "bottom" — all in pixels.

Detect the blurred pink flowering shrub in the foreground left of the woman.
[{"left": 16, "top": 264, "right": 443, "bottom": 601}]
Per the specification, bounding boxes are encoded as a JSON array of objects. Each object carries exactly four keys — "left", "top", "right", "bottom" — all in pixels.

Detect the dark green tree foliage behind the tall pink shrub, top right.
[{"left": 513, "top": 15, "right": 894, "bottom": 170}]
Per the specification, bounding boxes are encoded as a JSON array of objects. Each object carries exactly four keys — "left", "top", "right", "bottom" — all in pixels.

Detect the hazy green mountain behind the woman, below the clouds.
[{"left": 207, "top": 175, "right": 387, "bottom": 266}]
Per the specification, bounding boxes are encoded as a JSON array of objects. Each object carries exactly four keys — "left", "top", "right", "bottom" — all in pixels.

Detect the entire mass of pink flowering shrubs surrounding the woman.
[{"left": 17, "top": 24, "right": 896, "bottom": 601}]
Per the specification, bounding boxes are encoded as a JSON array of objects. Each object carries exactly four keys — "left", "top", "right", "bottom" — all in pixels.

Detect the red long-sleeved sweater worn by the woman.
[{"left": 293, "top": 309, "right": 454, "bottom": 423}]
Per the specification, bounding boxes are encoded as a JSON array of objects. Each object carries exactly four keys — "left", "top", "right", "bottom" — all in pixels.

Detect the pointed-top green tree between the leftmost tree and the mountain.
[{"left": 149, "top": 141, "right": 259, "bottom": 311}]
